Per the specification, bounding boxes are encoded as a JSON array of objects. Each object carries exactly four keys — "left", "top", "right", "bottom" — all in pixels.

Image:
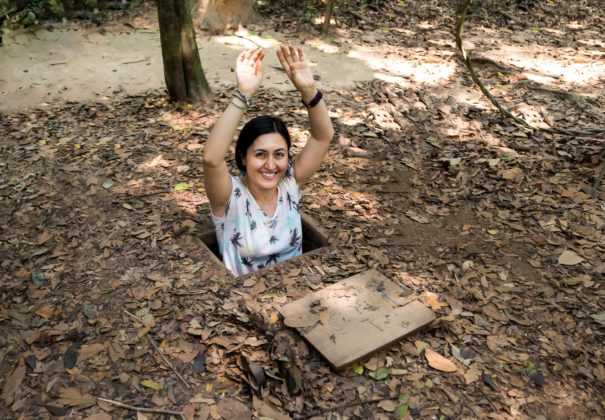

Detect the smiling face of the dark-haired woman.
[{"left": 243, "top": 133, "right": 288, "bottom": 190}]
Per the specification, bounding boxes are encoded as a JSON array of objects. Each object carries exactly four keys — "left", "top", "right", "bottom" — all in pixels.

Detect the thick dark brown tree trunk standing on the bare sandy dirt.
[{"left": 157, "top": 0, "right": 212, "bottom": 103}]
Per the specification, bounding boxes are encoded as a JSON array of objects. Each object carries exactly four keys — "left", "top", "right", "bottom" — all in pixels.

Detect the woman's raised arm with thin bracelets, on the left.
[{"left": 203, "top": 49, "right": 265, "bottom": 217}]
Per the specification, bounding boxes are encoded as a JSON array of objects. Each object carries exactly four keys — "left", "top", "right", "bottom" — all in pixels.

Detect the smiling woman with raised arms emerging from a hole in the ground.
[{"left": 203, "top": 46, "right": 334, "bottom": 276}]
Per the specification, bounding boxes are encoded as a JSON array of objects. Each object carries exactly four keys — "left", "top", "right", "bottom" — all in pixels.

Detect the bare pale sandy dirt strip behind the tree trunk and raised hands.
[{"left": 0, "top": 11, "right": 373, "bottom": 112}]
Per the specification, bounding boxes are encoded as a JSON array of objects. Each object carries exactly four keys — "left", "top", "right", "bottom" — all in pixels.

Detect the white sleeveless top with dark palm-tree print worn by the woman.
[{"left": 212, "top": 161, "right": 302, "bottom": 276}]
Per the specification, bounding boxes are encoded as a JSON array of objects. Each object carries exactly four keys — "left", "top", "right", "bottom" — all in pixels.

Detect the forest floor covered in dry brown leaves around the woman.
[{"left": 0, "top": 0, "right": 605, "bottom": 419}]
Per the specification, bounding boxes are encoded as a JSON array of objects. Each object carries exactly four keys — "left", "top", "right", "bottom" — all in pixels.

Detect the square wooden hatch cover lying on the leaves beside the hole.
[{"left": 280, "top": 270, "right": 435, "bottom": 369}]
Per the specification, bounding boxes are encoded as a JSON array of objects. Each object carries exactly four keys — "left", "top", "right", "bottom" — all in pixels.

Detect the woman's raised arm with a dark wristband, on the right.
[{"left": 277, "top": 45, "right": 334, "bottom": 186}]
